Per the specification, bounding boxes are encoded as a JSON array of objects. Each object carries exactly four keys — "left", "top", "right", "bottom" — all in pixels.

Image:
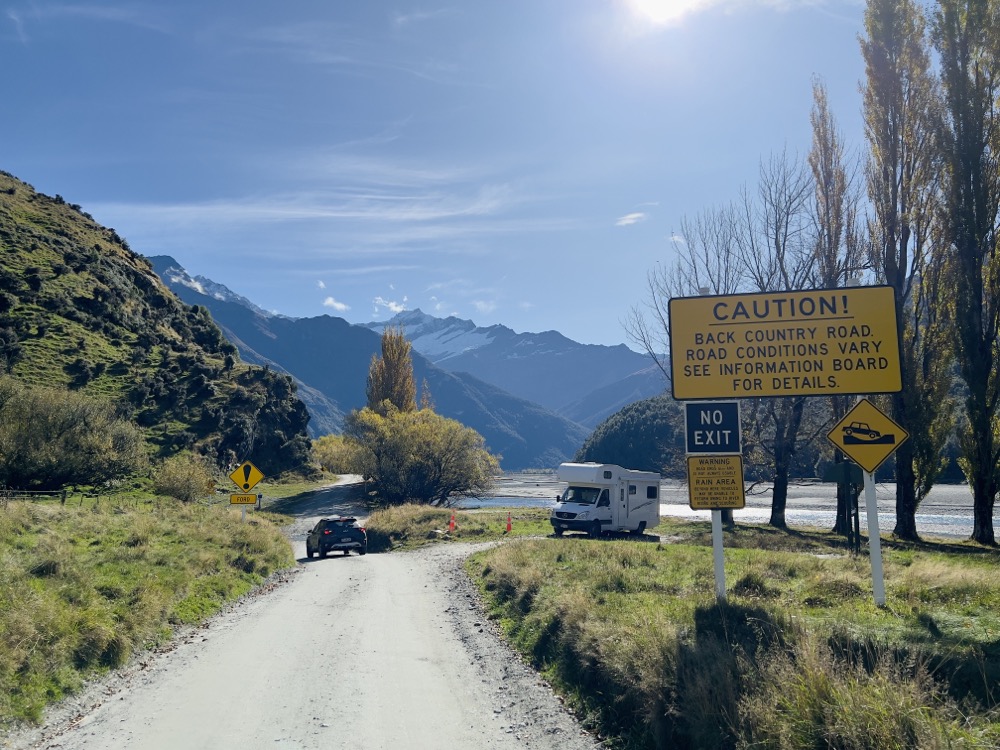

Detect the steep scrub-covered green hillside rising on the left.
[{"left": 0, "top": 172, "right": 309, "bottom": 476}]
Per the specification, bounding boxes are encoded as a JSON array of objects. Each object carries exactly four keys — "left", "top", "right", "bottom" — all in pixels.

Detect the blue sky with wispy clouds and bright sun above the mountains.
[{"left": 0, "top": 0, "right": 864, "bottom": 344}]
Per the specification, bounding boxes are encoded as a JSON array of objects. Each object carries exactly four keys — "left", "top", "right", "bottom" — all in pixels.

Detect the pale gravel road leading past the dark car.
[{"left": 0, "top": 487, "right": 597, "bottom": 750}]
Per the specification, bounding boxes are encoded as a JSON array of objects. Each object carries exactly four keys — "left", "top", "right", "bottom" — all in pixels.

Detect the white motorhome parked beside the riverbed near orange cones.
[{"left": 549, "top": 463, "right": 660, "bottom": 537}]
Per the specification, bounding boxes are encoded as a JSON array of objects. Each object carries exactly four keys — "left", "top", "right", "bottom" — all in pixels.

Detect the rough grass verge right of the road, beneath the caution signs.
[{"left": 467, "top": 521, "right": 1000, "bottom": 750}]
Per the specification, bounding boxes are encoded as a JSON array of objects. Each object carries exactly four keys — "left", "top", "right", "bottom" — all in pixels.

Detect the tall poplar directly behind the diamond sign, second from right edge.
[{"left": 861, "top": 0, "right": 953, "bottom": 541}]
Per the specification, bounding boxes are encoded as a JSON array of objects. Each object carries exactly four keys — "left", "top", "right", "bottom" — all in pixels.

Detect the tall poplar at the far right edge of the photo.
[{"left": 931, "top": 0, "right": 1000, "bottom": 545}]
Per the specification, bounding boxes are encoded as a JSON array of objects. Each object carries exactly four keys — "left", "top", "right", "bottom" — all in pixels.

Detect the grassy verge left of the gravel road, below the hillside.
[{"left": 0, "top": 501, "right": 294, "bottom": 725}]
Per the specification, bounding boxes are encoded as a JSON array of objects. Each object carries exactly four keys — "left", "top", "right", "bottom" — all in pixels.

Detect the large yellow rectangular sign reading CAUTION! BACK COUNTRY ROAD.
[{"left": 669, "top": 286, "right": 903, "bottom": 401}]
